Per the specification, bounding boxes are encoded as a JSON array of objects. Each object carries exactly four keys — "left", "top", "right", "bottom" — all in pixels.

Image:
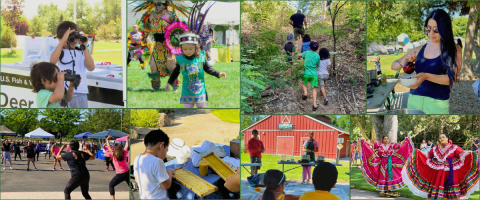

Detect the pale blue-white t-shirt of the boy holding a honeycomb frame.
[{"left": 133, "top": 154, "right": 169, "bottom": 199}]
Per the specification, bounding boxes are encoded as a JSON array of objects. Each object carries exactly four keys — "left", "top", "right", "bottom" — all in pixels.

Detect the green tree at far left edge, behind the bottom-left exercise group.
[{"left": 2, "top": 109, "right": 40, "bottom": 138}]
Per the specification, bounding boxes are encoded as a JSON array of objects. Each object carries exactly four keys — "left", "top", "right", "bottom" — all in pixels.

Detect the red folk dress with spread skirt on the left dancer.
[{"left": 359, "top": 137, "right": 414, "bottom": 192}]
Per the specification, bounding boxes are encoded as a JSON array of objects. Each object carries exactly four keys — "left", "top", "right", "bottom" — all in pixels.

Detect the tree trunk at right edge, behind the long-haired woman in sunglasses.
[{"left": 458, "top": 3, "right": 480, "bottom": 80}]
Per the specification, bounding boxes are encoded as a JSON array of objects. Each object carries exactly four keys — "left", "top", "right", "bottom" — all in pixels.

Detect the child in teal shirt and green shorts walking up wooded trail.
[{"left": 299, "top": 41, "right": 320, "bottom": 111}]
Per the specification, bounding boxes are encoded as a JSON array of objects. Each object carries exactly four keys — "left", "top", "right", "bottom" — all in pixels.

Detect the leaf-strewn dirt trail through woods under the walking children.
[{"left": 254, "top": 32, "right": 366, "bottom": 114}]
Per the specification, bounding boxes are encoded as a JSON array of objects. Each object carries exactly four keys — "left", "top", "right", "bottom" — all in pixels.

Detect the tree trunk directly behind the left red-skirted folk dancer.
[{"left": 370, "top": 115, "right": 398, "bottom": 142}]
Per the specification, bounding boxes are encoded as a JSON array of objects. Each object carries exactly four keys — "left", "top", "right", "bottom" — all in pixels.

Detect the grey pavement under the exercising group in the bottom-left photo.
[{"left": 1, "top": 156, "right": 129, "bottom": 199}]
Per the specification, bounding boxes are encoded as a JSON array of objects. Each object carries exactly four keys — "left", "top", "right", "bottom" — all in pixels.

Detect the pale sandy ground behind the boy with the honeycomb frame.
[{"left": 130, "top": 109, "right": 240, "bottom": 161}]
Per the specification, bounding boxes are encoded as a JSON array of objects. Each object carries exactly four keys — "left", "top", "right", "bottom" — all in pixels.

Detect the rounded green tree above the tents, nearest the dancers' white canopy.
[{"left": 42, "top": 109, "right": 82, "bottom": 143}]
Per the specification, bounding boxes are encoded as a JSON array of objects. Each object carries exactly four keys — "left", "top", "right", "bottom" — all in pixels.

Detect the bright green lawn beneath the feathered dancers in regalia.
[{"left": 127, "top": 61, "right": 240, "bottom": 108}]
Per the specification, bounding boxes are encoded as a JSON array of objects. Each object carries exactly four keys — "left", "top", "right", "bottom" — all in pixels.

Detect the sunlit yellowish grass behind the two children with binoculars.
[{"left": 0, "top": 42, "right": 122, "bottom": 66}]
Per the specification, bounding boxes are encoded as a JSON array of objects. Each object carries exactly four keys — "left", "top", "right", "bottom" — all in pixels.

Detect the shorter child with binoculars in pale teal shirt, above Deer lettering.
[{"left": 30, "top": 62, "right": 75, "bottom": 108}]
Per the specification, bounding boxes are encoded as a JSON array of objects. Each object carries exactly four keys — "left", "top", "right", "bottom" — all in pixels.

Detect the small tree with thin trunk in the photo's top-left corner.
[{"left": 2, "top": 0, "right": 25, "bottom": 53}]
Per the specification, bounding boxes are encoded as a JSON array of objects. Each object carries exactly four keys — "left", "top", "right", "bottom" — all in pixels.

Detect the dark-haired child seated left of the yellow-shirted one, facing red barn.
[{"left": 258, "top": 169, "right": 298, "bottom": 200}]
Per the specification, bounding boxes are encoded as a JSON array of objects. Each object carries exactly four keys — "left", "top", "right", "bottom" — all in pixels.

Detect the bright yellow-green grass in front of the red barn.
[{"left": 241, "top": 153, "right": 350, "bottom": 183}]
